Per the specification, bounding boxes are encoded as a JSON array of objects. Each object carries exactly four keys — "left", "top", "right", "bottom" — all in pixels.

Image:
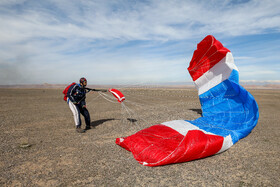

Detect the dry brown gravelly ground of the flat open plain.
[{"left": 0, "top": 88, "right": 280, "bottom": 186}]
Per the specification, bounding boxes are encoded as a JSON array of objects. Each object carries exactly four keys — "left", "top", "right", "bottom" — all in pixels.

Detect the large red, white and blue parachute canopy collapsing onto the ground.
[{"left": 116, "top": 35, "right": 259, "bottom": 166}]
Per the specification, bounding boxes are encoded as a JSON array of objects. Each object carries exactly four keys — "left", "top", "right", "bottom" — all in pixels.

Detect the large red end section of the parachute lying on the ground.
[{"left": 116, "top": 124, "right": 224, "bottom": 167}]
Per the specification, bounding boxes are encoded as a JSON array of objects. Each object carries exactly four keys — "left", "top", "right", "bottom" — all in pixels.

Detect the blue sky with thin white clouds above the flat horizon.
[{"left": 0, "top": 0, "right": 280, "bottom": 85}]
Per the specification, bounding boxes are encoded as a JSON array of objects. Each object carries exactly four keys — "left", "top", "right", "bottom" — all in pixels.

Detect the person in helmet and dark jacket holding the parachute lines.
[{"left": 67, "top": 77, "right": 106, "bottom": 133}]
